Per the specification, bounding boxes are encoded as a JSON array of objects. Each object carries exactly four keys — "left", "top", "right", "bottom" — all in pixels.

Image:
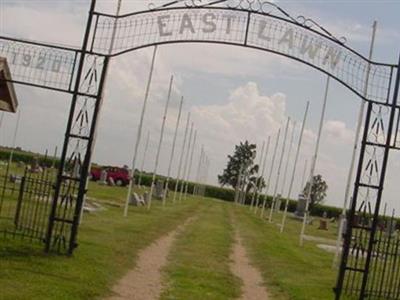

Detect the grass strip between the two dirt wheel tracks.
[{"left": 161, "top": 200, "right": 240, "bottom": 300}]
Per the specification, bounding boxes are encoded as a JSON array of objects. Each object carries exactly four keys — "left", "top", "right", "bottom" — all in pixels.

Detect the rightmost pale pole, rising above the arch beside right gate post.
[{"left": 332, "top": 21, "right": 378, "bottom": 268}]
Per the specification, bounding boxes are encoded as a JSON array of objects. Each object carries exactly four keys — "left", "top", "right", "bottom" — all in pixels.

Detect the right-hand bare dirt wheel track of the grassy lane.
[{"left": 231, "top": 233, "right": 269, "bottom": 300}]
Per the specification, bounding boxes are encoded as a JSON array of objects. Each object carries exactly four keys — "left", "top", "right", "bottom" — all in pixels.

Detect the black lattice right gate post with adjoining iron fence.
[{"left": 335, "top": 61, "right": 400, "bottom": 300}]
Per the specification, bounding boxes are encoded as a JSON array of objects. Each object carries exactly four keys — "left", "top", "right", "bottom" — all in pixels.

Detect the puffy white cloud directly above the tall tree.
[{"left": 192, "top": 82, "right": 286, "bottom": 143}]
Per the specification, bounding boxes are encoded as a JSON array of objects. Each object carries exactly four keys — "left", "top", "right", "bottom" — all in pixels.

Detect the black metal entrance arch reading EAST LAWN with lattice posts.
[{"left": 0, "top": 0, "right": 400, "bottom": 299}]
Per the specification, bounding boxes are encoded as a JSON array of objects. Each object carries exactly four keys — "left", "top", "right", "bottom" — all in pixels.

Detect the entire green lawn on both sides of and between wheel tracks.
[{"left": 0, "top": 176, "right": 350, "bottom": 300}]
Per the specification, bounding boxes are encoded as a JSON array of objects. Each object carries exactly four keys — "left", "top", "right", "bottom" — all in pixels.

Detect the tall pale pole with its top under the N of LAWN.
[{"left": 300, "top": 76, "right": 330, "bottom": 246}]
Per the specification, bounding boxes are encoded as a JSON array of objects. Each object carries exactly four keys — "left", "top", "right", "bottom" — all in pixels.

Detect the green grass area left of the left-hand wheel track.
[{"left": 0, "top": 188, "right": 199, "bottom": 300}]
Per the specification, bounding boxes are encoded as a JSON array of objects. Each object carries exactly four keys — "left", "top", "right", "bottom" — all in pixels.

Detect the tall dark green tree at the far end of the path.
[{"left": 218, "top": 141, "right": 265, "bottom": 192}]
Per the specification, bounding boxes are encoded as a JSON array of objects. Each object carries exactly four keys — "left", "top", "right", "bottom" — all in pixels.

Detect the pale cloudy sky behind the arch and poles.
[{"left": 0, "top": 0, "right": 400, "bottom": 209}]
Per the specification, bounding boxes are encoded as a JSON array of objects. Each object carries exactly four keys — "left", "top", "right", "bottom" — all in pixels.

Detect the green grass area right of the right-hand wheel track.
[{"left": 234, "top": 207, "right": 337, "bottom": 300}]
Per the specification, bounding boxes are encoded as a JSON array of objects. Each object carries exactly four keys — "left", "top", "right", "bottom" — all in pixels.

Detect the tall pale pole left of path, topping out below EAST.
[{"left": 124, "top": 46, "right": 157, "bottom": 217}]
